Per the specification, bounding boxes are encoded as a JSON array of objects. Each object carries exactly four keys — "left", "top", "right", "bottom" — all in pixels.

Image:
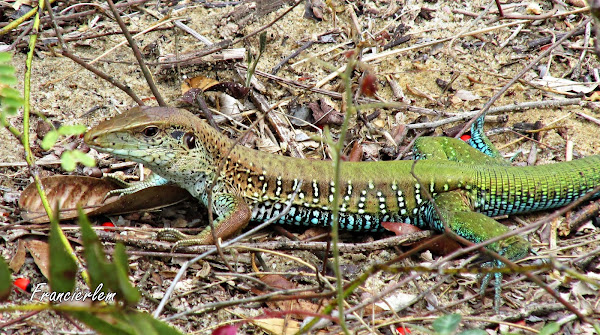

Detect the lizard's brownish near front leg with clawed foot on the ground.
[{"left": 157, "top": 193, "right": 252, "bottom": 249}]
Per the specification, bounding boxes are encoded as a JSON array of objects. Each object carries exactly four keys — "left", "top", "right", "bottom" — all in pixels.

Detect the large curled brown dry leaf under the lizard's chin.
[{"left": 19, "top": 176, "right": 190, "bottom": 223}]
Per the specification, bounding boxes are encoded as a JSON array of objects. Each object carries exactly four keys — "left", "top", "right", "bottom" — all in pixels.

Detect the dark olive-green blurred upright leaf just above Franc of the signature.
[{"left": 48, "top": 217, "right": 77, "bottom": 292}]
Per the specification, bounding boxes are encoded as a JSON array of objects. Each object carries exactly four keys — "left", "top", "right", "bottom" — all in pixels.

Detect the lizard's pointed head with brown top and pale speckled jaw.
[{"left": 84, "top": 106, "right": 207, "bottom": 170}]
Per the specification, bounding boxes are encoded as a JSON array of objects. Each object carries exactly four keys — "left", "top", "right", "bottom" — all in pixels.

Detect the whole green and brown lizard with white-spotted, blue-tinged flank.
[{"left": 85, "top": 107, "right": 600, "bottom": 308}]
